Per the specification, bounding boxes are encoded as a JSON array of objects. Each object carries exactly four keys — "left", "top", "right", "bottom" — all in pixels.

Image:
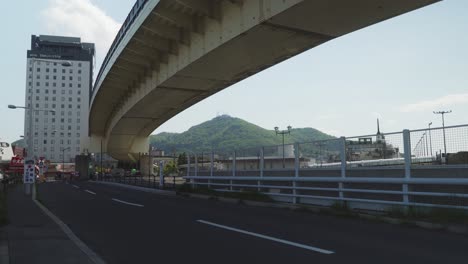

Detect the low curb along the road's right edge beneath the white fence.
[{"left": 178, "top": 192, "right": 468, "bottom": 235}]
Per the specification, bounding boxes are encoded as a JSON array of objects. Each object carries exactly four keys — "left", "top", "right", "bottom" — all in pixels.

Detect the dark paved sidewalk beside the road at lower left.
[{"left": 0, "top": 184, "right": 94, "bottom": 264}]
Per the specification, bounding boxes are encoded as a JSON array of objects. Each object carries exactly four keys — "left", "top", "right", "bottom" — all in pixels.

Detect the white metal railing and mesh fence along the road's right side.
[{"left": 185, "top": 125, "right": 468, "bottom": 209}]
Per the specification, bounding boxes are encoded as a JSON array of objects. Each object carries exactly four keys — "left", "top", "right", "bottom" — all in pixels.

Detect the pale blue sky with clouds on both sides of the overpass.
[{"left": 0, "top": 0, "right": 468, "bottom": 142}]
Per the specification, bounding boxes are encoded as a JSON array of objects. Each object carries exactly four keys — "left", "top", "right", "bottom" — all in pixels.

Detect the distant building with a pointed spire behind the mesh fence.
[{"left": 346, "top": 119, "right": 401, "bottom": 161}]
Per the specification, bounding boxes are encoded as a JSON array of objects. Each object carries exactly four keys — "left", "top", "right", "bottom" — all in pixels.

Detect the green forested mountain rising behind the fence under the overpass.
[{"left": 150, "top": 115, "right": 335, "bottom": 154}]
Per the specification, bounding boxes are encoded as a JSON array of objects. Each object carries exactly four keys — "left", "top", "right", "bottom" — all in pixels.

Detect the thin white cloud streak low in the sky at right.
[{"left": 399, "top": 93, "right": 468, "bottom": 113}]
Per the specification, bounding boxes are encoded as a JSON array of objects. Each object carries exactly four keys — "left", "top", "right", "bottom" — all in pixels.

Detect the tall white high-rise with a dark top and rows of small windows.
[{"left": 24, "top": 35, "right": 95, "bottom": 162}]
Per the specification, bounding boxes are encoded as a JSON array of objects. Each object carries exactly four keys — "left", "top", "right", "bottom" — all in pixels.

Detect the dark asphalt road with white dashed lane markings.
[{"left": 38, "top": 182, "right": 468, "bottom": 264}]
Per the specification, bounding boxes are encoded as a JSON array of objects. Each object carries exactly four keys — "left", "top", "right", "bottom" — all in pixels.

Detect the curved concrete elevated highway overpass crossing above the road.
[{"left": 89, "top": 0, "right": 437, "bottom": 160}]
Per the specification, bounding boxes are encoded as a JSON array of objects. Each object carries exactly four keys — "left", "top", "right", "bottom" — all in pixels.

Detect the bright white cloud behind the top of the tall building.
[{"left": 41, "top": 0, "right": 121, "bottom": 67}]
